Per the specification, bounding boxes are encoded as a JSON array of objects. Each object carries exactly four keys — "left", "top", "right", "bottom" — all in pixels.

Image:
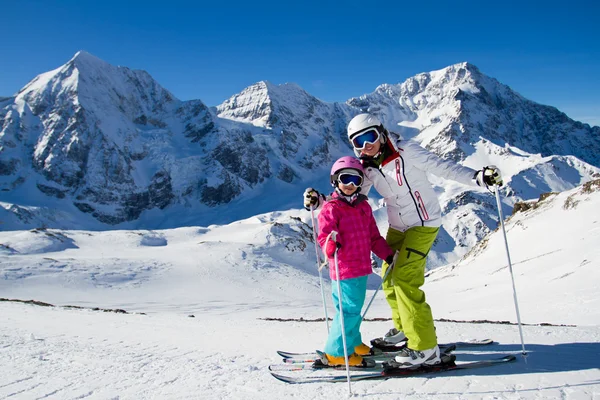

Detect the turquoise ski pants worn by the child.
[{"left": 324, "top": 276, "right": 368, "bottom": 357}]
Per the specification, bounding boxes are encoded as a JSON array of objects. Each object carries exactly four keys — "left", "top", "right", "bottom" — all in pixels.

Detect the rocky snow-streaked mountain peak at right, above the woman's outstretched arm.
[{"left": 348, "top": 63, "right": 600, "bottom": 166}]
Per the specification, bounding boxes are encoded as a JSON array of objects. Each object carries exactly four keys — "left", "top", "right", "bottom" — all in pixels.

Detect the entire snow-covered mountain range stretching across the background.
[{"left": 0, "top": 52, "right": 600, "bottom": 265}]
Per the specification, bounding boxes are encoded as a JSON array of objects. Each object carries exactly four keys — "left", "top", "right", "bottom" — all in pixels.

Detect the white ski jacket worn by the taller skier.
[{"left": 361, "top": 138, "right": 477, "bottom": 232}]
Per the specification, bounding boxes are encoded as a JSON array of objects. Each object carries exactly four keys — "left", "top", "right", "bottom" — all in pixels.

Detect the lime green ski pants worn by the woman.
[{"left": 382, "top": 226, "right": 439, "bottom": 350}]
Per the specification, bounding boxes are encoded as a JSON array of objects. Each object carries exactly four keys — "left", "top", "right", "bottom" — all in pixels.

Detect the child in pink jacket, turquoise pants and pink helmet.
[{"left": 318, "top": 157, "right": 394, "bottom": 366}]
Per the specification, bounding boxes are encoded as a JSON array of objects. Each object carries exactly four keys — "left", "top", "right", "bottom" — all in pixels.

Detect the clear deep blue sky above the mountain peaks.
[{"left": 0, "top": 0, "right": 600, "bottom": 125}]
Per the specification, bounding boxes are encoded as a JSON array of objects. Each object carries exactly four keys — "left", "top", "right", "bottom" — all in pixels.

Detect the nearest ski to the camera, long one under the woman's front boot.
[{"left": 271, "top": 355, "right": 517, "bottom": 384}]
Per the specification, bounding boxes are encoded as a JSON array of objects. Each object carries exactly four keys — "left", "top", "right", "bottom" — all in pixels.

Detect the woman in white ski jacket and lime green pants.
[{"left": 304, "top": 114, "right": 502, "bottom": 367}]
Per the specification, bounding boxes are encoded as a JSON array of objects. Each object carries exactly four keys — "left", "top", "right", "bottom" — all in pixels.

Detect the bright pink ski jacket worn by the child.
[{"left": 317, "top": 192, "right": 394, "bottom": 280}]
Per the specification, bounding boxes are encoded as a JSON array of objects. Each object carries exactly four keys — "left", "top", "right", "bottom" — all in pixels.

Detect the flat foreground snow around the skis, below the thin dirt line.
[{"left": 0, "top": 302, "right": 600, "bottom": 399}]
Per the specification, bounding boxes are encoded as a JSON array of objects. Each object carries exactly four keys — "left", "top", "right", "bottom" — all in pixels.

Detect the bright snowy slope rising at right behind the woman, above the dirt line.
[{"left": 425, "top": 180, "right": 600, "bottom": 325}]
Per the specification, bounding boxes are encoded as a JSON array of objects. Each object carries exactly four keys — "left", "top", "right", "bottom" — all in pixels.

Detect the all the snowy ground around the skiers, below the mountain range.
[{"left": 0, "top": 184, "right": 600, "bottom": 400}]
